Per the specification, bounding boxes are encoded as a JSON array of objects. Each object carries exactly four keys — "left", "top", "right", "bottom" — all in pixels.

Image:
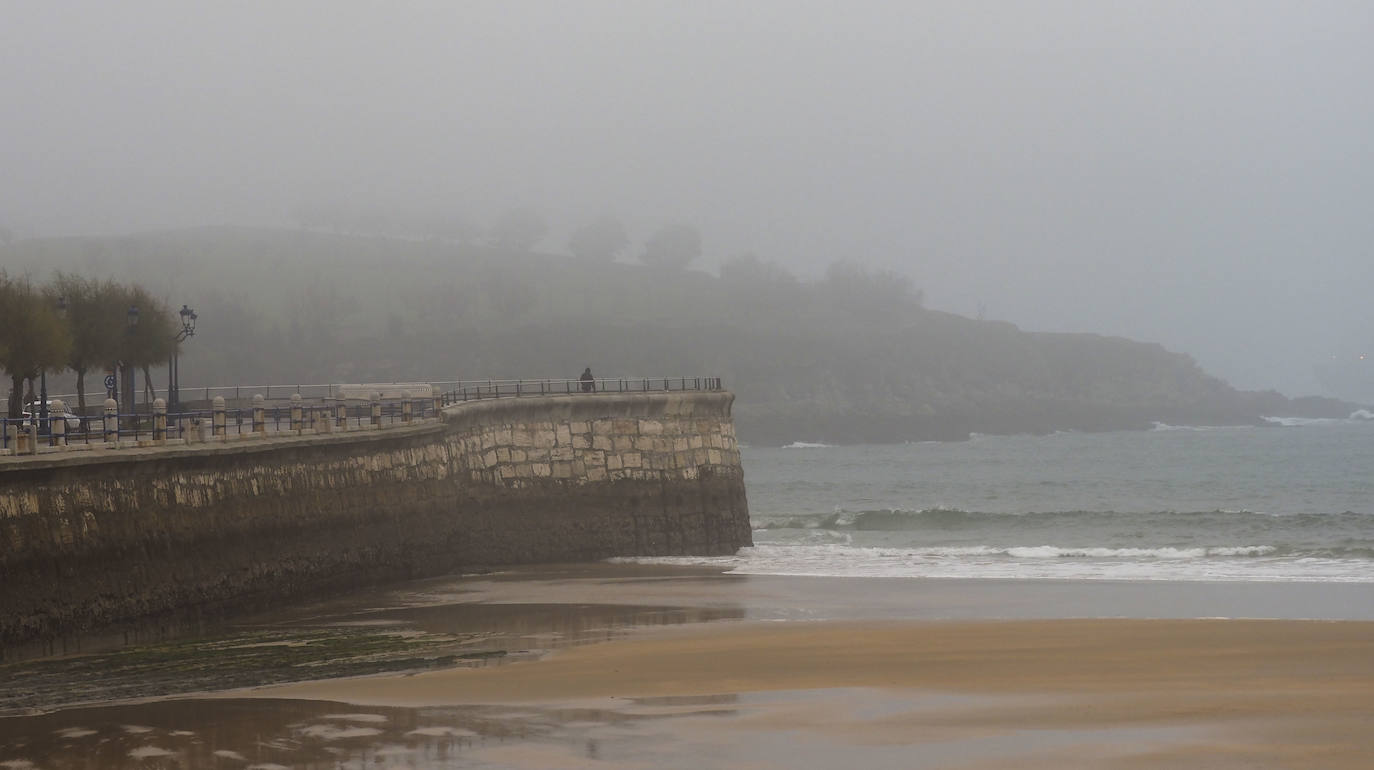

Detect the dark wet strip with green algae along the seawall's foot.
[{"left": 0, "top": 572, "right": 743, "bottom": 715}]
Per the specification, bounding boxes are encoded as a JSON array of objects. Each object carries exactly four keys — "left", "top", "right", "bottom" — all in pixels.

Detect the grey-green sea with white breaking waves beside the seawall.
[{"left": 629, "top": 413, "right": 1374, "bottom": 583}]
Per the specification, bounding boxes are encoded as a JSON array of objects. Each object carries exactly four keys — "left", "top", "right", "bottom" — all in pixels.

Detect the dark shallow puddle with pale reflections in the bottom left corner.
[{"left": 0, "top": 696, "right": 738, "bottom": 770}]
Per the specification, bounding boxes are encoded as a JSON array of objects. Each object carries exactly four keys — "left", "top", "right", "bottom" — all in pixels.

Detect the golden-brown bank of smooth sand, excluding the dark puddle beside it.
[{"left": 254, "top": 620, "right": 1374, "bottom": 769}]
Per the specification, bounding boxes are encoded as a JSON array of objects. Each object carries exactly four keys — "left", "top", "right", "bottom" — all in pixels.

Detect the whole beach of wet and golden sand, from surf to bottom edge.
[{"left": 0, "top": 565, "right": 1374, "bottom": 770}]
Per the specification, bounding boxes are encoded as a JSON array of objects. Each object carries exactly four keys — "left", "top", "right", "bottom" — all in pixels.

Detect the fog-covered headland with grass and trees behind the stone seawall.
[{"left": 0, "top": 228, "right": 1352, "bottom": 443}]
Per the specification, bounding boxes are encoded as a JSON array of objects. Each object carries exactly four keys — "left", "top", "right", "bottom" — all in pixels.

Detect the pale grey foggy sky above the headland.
[{"left": 0, "top": 0, "right": 1374, "bottom": 393}]
